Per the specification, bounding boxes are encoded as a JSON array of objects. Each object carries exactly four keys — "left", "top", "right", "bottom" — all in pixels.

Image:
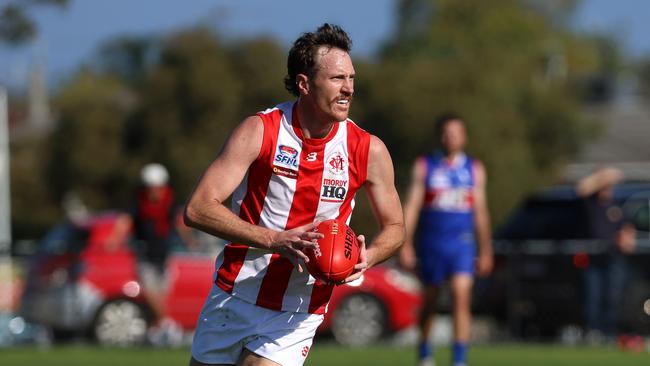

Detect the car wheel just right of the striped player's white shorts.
[{"left": 332, "top": 294, "right": 387, "bottom": 346}]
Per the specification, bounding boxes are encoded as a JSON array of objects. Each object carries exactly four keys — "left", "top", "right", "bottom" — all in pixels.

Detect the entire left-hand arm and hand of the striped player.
[{"left": 184, "top": 116, "right": 322, "bottom": 260}]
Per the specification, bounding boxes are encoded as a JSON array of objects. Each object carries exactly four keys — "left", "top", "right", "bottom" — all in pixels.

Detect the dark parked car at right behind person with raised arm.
[{"left": 486, "top": 183, "right": 650, "bottom": 339}]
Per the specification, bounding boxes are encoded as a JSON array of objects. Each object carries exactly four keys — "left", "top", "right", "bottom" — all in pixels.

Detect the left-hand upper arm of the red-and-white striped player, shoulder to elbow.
[{"left": 192, "top": 116, "right": 264, "bottom": 202}]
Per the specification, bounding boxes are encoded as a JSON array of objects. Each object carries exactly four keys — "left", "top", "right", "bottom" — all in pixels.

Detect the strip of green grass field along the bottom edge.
[{"left": 0, "top": 344, "right": 650, "bottom": 366}]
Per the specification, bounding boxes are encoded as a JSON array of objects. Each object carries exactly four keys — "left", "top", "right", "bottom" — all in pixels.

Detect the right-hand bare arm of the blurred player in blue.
[{"left": 473, "top": 161, "right": 494, "bottom": 276}]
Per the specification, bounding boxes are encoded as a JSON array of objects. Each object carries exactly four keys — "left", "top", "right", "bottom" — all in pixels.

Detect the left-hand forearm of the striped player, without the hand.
[{"left": 184, "top": 201, "right": 275, "bottom": 249}]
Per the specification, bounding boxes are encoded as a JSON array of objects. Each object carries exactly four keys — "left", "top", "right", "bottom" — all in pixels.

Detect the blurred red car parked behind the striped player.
[{"left": 20, "top": 214, "right": 420, "bottom": 345}]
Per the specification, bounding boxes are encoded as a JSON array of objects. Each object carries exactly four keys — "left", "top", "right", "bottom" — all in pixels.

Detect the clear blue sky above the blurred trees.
[{"left": 0, "top": 0, "right": 650, "bottom": 91}]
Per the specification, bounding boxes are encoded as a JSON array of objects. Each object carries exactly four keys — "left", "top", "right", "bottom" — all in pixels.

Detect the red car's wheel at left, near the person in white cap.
[{"left": 93, "top": 300, "right": 149, "bottom": 346}]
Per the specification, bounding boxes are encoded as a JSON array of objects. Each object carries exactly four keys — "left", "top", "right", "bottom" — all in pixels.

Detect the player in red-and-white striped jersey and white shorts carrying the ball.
[{"left": 185, "top": 24, "right": 404, "bottom": 365}]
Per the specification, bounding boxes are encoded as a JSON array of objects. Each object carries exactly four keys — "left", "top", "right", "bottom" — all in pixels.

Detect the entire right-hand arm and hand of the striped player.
[{"left": 344, "top": 136, "right": 404, "bottom": 282}]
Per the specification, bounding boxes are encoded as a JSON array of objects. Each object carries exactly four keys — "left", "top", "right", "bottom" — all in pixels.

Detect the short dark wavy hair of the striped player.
[{"left": 284, "top": 23, "right": 352, "bottom": 96}]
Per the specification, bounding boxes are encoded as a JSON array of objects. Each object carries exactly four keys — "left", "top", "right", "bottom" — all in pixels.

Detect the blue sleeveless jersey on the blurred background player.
[{"left": 418, "top": 152, "right": 474, "bottom": 247}]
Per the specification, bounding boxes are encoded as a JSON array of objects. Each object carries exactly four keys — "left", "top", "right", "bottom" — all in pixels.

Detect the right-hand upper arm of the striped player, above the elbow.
[{"left": 366, "top": 136, "right": 404, "bottom": 228}]
